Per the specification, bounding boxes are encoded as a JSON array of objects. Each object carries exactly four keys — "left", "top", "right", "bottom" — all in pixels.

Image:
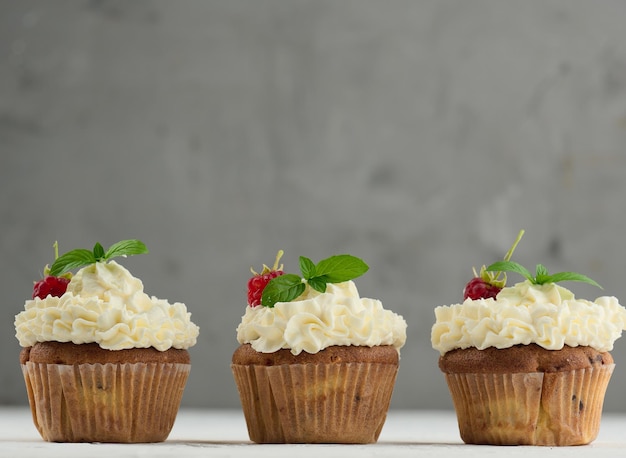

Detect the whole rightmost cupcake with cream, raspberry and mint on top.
[{"left": 431, "top": 231, "right": 626, "bottom": 446}]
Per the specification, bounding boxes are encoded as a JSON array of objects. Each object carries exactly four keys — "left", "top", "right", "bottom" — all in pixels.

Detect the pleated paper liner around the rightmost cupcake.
[{"left": 446, "top": 364, "right": 615, "bottom": 446}]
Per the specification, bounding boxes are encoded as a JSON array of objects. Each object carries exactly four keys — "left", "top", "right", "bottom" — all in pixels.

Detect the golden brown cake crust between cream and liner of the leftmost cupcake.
[{"left": 20, "top": 342, "right": 190, "bottom": 365}]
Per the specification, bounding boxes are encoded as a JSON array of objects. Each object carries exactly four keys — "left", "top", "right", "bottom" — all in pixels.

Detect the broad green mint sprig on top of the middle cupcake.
[{"left": 261, "top": 254, "right": 369, "bottom": 307}]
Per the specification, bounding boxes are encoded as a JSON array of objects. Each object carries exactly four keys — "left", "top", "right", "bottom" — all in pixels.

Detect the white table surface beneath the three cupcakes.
[{"left": 0, "top": 407, "right": 626, "bottom": 458}]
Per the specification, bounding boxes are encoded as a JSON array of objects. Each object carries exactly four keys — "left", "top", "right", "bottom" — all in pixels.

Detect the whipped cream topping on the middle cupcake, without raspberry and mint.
[{"left": 237, "top": 281, "right": 407, "bottom": 355}]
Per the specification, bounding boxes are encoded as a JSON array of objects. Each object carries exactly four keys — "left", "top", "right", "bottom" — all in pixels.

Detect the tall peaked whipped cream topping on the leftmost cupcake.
[{"left": 15, "top": 261, "right": 199, "bottom": 351}]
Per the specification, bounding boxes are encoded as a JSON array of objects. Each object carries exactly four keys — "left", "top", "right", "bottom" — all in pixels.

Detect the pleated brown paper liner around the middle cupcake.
[{"left": 231, "top": 363, "right": 398, "bottom": 443}]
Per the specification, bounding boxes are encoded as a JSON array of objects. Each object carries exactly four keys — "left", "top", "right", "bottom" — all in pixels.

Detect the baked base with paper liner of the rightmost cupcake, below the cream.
[{"left": 440, "top": 345, "right": 615, "bottom": 446}]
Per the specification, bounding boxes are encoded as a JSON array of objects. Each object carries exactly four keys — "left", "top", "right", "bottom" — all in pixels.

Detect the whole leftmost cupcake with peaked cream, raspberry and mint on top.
[{"left": 15, "top": 240, "right": 198, "bottom": 443}]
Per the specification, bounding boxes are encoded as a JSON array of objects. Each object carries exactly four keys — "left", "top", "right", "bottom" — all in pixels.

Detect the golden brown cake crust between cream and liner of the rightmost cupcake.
[{"left": 439, "top": 344, "right": 613, "bottom": 374}]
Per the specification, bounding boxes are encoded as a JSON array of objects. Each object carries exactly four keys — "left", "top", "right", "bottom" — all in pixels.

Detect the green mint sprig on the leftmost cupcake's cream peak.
[{"left": 49, "top": 240, "right": 148, "bottom": 277}]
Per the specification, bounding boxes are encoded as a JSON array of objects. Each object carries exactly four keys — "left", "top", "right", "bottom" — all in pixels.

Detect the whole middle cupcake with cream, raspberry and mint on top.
[{"left": 231, "top": 252, "right": 406, "bottom": 444}]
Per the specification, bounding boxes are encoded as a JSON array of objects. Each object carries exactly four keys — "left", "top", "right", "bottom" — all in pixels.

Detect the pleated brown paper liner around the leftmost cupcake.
[{"left": 22, "top": 362, "right": 191, "bottom": 443}]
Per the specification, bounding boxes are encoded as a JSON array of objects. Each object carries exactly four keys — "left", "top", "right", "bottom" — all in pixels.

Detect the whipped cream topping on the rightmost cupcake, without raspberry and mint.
[{"left": 431, "top": 281, "right": 626, "bottom": 354}]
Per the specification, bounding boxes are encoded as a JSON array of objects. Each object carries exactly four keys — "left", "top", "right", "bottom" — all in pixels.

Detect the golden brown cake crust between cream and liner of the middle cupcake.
[{"left": 232, "top": 344, "right": 399, "bottom": 366}]
